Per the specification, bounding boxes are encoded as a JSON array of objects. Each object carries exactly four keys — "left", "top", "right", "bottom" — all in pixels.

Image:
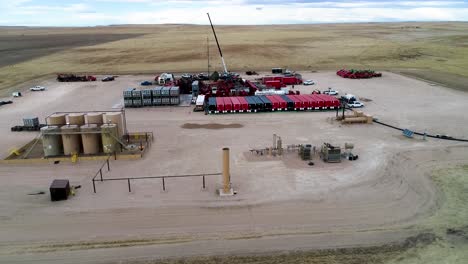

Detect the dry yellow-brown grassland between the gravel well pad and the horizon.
[{"left": 0, "top": 23, "right": 468, "bottom": 93}]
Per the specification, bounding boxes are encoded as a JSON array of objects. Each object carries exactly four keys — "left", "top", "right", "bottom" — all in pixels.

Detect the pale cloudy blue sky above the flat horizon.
[{"left": 0, "top": 0, "right": 468, "bottom": 26}]
